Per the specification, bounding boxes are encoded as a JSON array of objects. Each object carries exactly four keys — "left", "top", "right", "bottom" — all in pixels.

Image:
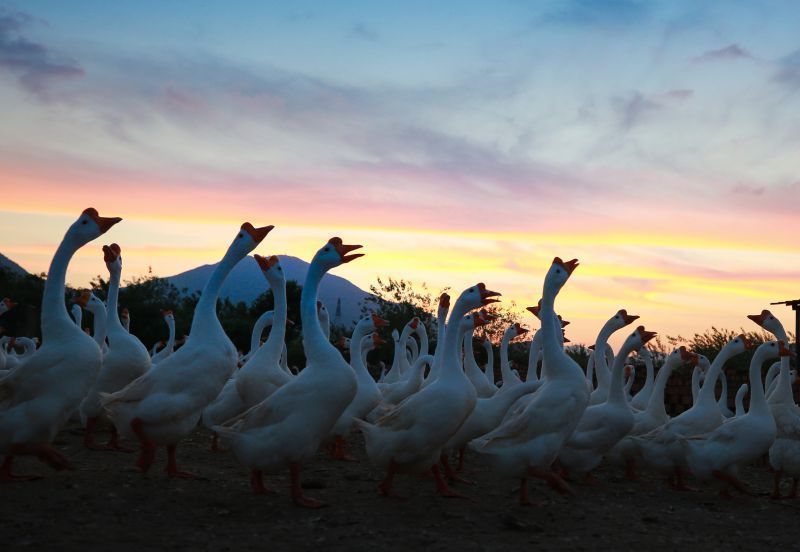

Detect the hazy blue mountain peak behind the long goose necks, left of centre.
[{"left": 166, "top": 255, "right": 370, "bottom": 327}]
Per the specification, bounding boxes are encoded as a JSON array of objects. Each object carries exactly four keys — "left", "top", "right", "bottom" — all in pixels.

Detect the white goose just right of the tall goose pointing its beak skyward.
[{"left": 558, "top": 326, "right": 656, "bottom": 477}]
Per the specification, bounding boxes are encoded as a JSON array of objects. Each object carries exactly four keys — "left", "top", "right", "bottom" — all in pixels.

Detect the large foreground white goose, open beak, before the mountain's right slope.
[{"left": 214, "top": 238, "right": 361, "bottom": 508}]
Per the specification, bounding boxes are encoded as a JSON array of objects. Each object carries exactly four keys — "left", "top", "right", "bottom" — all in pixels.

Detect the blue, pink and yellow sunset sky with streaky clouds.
[{"left": 0, "top": 0, "right": 800, "bottom": 342}]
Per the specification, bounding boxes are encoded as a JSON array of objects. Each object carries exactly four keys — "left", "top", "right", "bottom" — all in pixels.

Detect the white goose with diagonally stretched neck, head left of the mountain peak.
[{"left": 101, "top": 222, "right": 273, "bottom": 477}]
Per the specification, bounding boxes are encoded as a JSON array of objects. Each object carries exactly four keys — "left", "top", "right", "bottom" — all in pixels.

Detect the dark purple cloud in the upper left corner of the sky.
[{"left": 0, "top": 8, "right": 85, "bottom": 96}]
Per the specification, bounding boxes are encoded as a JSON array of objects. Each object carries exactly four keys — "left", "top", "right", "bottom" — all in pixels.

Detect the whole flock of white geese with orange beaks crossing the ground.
[{"left": 0, "top": 208, "right": 800, "bottom": 508}]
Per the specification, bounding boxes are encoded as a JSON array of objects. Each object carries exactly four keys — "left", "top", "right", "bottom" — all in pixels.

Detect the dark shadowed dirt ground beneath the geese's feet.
[{"left": 0, "top": 428, "right": 800, "bottom": 552}]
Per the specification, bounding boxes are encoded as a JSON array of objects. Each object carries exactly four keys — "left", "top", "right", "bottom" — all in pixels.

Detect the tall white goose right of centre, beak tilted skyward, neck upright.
[{"left": 470, "top": 257, "right": 589, "bottom": 504}]
